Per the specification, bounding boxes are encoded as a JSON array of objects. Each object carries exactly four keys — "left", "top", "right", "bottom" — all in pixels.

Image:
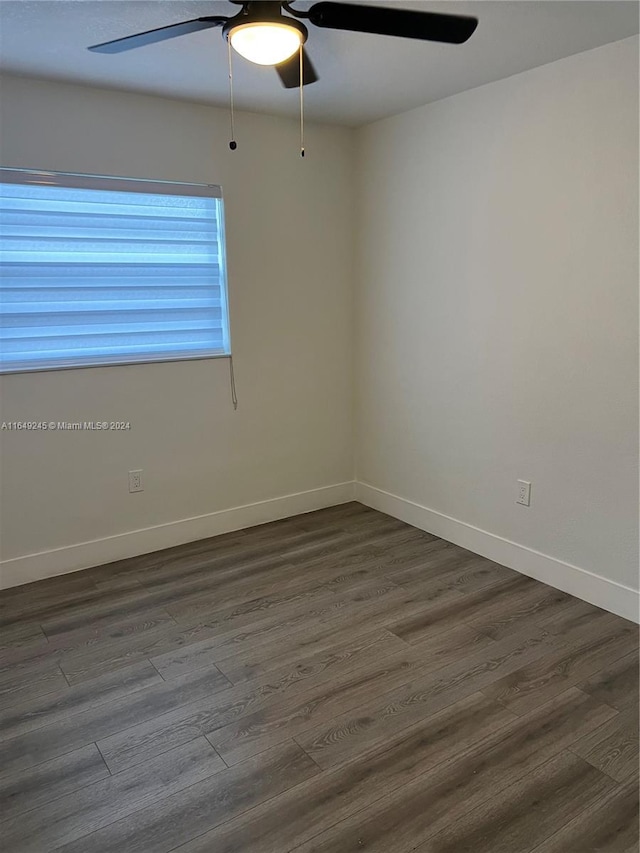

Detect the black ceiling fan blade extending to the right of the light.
[{"left": 306, "top": 2, "right": 478, "bottom": 44}]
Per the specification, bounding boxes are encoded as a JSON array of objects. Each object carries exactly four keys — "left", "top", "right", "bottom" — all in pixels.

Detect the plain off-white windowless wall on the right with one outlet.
[{"left": 355, "top": 38, "right": 638, "bottom": 615}]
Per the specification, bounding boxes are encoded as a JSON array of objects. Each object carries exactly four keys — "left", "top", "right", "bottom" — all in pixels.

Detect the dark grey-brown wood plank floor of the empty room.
[{"left": 0, "top": 503, "right": 638, "bottom": 853}]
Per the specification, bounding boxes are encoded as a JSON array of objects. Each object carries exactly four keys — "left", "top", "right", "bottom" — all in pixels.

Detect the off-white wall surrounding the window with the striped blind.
[{"left": 0, "top": 77, "right": 353, "bottom": 585}]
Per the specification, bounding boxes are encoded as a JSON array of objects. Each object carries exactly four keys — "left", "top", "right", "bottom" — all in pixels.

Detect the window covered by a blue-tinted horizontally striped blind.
[{"left": 0, "top": 169, "right": 230, "bottom": 373}]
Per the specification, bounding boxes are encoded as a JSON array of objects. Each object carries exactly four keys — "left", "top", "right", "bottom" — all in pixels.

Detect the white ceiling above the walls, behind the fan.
[{"left": 0, "top": 0, "right": 638, "bottom": 126}]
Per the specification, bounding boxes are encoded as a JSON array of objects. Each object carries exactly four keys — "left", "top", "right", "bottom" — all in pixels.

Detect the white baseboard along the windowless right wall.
[{"left": 355, "top": 482, "right": 640, "bottom": 622}]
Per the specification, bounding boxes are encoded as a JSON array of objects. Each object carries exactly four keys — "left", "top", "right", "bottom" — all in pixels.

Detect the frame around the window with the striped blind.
[{"left": 0, "top": 166, "right": 232, "bottom": 376}]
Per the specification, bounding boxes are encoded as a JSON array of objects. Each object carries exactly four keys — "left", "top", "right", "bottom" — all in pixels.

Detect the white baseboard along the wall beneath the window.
[{"left": 0, "top": 482, "right": 354, "bottom": 589}]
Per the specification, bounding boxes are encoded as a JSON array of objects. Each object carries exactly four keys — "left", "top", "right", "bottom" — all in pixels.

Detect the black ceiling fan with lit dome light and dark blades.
[{"left": 89, "top": 0, "right": 478, "bottom": 89}]
